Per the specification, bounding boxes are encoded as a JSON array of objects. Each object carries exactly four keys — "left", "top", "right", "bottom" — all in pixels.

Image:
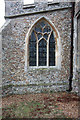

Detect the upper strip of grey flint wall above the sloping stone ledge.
[{"left": 5, "top": 0, "right": 72, "bottom": 17}]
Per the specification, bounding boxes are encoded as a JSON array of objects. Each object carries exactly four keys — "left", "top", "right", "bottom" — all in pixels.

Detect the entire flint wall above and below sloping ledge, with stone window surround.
[{"left": 0, "top": 0, "right": 79, "bottom": 95}]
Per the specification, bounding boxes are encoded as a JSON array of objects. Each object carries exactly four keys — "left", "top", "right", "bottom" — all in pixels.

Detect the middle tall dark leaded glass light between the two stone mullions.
[{"left": 39, "top": 39, "right": 47, "bottom": 66}]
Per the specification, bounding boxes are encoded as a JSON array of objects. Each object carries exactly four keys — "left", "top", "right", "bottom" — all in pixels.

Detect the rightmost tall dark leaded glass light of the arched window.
[{"left": 49, "top": 32, "right": 55, "bottom": 66}]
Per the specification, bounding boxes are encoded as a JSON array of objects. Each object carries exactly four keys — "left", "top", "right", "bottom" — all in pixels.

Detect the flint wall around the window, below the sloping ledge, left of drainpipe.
[{"left": 2, "top": 2, "right": 71, "bottom": 95}]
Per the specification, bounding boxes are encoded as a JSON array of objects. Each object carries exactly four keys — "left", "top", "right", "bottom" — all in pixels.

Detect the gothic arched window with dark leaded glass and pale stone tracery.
[{"left": 29, "top": 19, "right": 56, "bottom": 66}]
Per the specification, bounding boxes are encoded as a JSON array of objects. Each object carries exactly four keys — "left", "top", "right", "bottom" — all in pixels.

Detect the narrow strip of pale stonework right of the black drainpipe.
[{"left": 73, "top": 2, "right": 80, "bottom": 95}]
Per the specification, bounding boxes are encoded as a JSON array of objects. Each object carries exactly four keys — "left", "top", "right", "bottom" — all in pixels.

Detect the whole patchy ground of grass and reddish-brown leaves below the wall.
[{"left": 2, "top": 92, "right": 79, "bottom": 120}]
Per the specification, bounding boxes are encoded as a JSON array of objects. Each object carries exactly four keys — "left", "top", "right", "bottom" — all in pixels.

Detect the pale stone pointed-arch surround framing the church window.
[{"left": 24, "top": 16, "right": 62, "bottom": 72}]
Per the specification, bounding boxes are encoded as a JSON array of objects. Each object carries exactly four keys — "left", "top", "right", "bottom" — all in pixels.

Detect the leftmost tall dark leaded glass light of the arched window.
[{"left": 29, "top": 31, "right": 36, "bottom": 66}]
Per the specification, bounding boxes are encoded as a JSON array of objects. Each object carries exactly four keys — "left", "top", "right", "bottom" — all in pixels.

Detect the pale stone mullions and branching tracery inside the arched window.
[{"left": 30, "top": 19, "right": 56, "bottom": 67}]
